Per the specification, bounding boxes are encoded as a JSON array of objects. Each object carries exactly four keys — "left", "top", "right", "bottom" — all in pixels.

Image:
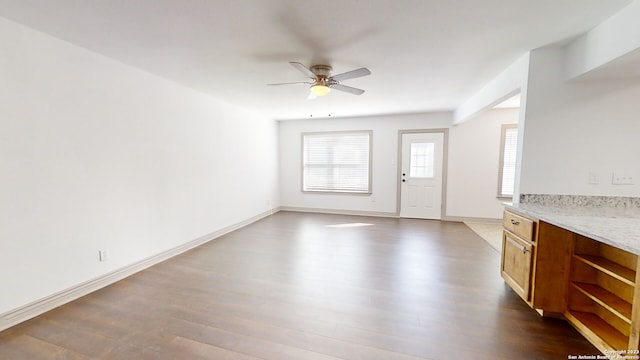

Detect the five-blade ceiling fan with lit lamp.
[{"left": 269, "top": 61, "right": 371, "bottom": 99}]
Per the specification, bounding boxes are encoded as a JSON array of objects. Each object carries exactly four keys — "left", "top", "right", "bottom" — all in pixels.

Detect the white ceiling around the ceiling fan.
[{"left": 0, "top": 0, "right": 631, "bottom": 119}]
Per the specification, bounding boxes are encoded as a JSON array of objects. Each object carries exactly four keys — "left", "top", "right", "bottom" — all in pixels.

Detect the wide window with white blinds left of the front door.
[{"left": 302, "top": 131, "right": 372, "bottom": 194}]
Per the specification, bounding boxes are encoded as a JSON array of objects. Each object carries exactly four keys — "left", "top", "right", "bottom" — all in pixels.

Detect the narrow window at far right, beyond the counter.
[{"left": 498, "top": 125, "right": 518, "bottom": 197}]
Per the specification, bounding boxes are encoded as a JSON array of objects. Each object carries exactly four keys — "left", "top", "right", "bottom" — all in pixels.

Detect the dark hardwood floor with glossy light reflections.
[{"left": 0, "top": 212, "right": 599, "bottom": 360}]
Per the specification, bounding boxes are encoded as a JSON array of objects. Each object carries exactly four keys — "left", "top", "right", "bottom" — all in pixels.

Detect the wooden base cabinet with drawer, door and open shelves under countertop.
[{"left": 501, "top": 209, "right": 640, "bottom": 356}]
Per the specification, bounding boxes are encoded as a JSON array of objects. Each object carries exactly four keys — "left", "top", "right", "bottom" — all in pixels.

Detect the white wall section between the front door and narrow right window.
[{"left": 447, "top": 109, "right": 519, "bottom": 219}]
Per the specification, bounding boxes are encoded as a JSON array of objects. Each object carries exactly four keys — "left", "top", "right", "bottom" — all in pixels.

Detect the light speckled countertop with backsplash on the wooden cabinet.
[{"left": 505, "top": 195, "right": 640, "bottom": 255}]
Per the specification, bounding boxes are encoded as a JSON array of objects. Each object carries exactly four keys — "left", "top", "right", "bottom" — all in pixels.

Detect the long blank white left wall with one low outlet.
[{"left": 0, "top": 19, "right": 279, "bottom": 314}]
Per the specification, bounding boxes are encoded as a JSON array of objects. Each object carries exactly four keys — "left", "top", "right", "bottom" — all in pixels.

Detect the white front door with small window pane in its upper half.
[{"left": 400, "top": 132, "right": 444, "bottom": 219}]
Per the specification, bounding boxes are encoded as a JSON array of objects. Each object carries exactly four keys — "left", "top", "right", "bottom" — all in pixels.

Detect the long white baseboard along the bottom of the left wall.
[{"left": 0, "top": 208, "right": 280, "bottom": 331}]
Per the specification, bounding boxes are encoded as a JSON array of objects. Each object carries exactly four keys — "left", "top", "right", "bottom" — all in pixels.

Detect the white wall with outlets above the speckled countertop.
[{"left": 520, "top": 48, "right": 640, "bottom": 196}]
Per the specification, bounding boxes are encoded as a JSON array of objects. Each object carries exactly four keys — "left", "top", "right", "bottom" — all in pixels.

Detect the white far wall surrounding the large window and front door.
[{"left": 279, "top": 111, "right": 510, "bottom": 218}]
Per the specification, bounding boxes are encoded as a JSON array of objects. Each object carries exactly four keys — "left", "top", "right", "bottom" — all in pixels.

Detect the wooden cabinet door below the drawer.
[{"left": 502, "top": 231, "right": 533, "bottom": 302}]
